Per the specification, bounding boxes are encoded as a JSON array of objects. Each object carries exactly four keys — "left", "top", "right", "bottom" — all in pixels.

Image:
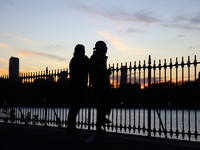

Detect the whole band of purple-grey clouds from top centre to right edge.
[{"left": 67, "top": 1, "right": 200, "bottom": 33}]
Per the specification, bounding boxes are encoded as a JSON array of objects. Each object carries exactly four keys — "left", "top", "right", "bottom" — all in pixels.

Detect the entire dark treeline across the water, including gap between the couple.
[{"left": 0, "top": 79, "right": 200, "bottom": 109}]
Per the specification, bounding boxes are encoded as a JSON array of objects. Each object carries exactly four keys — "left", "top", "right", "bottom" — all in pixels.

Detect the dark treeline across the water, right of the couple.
[{"left": 115, "top": 82, "right": 200, "bottom": 109}]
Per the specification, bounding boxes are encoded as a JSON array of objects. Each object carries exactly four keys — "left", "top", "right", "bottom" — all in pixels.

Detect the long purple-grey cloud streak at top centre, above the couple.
[{"left": 67, "top": 1, "right": 159, "bottom": 23}]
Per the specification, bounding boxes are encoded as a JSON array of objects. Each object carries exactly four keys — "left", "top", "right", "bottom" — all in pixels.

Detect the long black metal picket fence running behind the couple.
[{"left": 0, "top": 56, "right": 200, "bottom": 141}]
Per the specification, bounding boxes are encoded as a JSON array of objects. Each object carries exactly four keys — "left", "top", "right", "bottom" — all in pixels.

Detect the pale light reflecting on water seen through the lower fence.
[{"left": 0, "top": 107, "right": 200, "bottom": 141}]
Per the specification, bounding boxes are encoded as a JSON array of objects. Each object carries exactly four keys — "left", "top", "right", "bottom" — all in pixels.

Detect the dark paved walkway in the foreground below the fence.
[{"left": 0, "top": 123, "right": 200, "bottom": 150}]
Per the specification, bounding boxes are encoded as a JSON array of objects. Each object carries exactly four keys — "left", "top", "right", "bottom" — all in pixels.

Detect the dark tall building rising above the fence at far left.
[{"left": 9, "top": 57, "right": 19, "bottom": 78}]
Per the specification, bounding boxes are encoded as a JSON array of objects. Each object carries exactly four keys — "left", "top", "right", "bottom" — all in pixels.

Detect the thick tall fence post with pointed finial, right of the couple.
[{"left": 147, "top": 55, "right": 151, "bottom": 138}]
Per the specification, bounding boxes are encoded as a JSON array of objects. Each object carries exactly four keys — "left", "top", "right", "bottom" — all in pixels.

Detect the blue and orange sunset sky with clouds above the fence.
[{"left": 0, "top": 0, "right": 200, "bottom": 75}]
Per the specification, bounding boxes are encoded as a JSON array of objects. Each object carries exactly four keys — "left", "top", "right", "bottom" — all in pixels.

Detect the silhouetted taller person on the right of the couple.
[{"left": 90, "top": 41, "right": 111, "bottom": 132}]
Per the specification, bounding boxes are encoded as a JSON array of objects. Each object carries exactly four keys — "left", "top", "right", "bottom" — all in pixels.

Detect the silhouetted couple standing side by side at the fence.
[{"left": 67, "top": 41, "right": 111, "bottom": 132}]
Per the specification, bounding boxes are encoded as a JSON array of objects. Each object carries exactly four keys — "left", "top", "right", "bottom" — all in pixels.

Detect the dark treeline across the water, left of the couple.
[{"left": 0, "top": 80, "right": 70, "bottom": 107}]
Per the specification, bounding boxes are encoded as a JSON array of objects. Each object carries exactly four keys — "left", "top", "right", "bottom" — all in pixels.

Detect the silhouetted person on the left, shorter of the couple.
[{"left": 67, "top": 44, "right": 89, "bottom": 129}]
